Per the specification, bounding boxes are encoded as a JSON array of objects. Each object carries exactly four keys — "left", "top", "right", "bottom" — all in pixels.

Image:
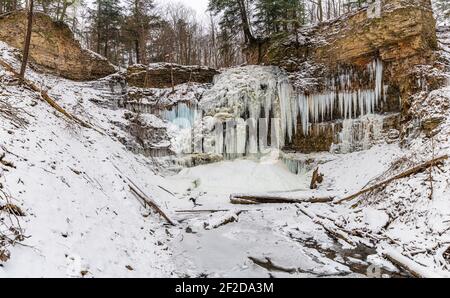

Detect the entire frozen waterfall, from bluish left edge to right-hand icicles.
[{"left": 167, "top": 59, "right": 387, "bottom": 158}]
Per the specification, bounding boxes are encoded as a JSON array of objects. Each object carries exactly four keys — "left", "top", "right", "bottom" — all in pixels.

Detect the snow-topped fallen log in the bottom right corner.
[{"left": 383, "top": 247, "right": 445, "bottom": 278}]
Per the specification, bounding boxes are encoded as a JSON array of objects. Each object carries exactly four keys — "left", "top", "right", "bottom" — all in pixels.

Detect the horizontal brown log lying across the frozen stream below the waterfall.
[{"left": 230, "top": 194, "right": 334, "bottom": 205}]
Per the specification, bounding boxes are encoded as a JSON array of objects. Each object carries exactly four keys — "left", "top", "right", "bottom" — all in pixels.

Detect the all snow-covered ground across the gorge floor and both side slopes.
[{"left": 0, "top": 27, "right": 450, "bottom": 277}]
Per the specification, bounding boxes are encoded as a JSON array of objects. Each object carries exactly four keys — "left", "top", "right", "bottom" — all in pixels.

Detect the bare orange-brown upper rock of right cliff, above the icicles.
[{"left": 247, "top": 0, "right": 442, "bottom": 103}]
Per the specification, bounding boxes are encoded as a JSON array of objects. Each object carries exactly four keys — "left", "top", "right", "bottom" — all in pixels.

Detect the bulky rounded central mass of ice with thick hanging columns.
[{"left": 201, "top": 66, "right": 298, "bottom": 157}]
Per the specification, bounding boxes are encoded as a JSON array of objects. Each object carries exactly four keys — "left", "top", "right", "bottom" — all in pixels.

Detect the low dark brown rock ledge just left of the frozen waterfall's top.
[{"left": 127, "top": 63, "right": 219, "bottom": 88}]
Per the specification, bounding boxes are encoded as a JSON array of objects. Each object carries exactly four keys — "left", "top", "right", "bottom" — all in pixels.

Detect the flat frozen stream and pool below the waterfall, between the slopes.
[{"left": 165, "top": 160, "right": 404, "bottom": 277}]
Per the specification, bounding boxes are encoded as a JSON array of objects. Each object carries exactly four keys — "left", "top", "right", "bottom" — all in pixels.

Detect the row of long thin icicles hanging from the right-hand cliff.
[{"left": 298, "top": 59, "right": 388, "bottom": 135}]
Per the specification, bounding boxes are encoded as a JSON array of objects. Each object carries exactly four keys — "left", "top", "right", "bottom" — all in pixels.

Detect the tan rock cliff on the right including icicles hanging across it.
[{"left": 246, "top": 0, "right": 445, "bottom": 153}]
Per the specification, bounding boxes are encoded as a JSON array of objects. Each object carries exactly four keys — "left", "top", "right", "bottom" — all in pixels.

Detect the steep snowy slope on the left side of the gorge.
[{"left": 0, "top": 45, "right": 179, "bottom": 277}]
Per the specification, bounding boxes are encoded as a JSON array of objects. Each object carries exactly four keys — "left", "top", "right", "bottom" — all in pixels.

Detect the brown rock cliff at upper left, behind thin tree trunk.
[{"left": 0, "top": 12, "right": 116, "bottom": 81}]
